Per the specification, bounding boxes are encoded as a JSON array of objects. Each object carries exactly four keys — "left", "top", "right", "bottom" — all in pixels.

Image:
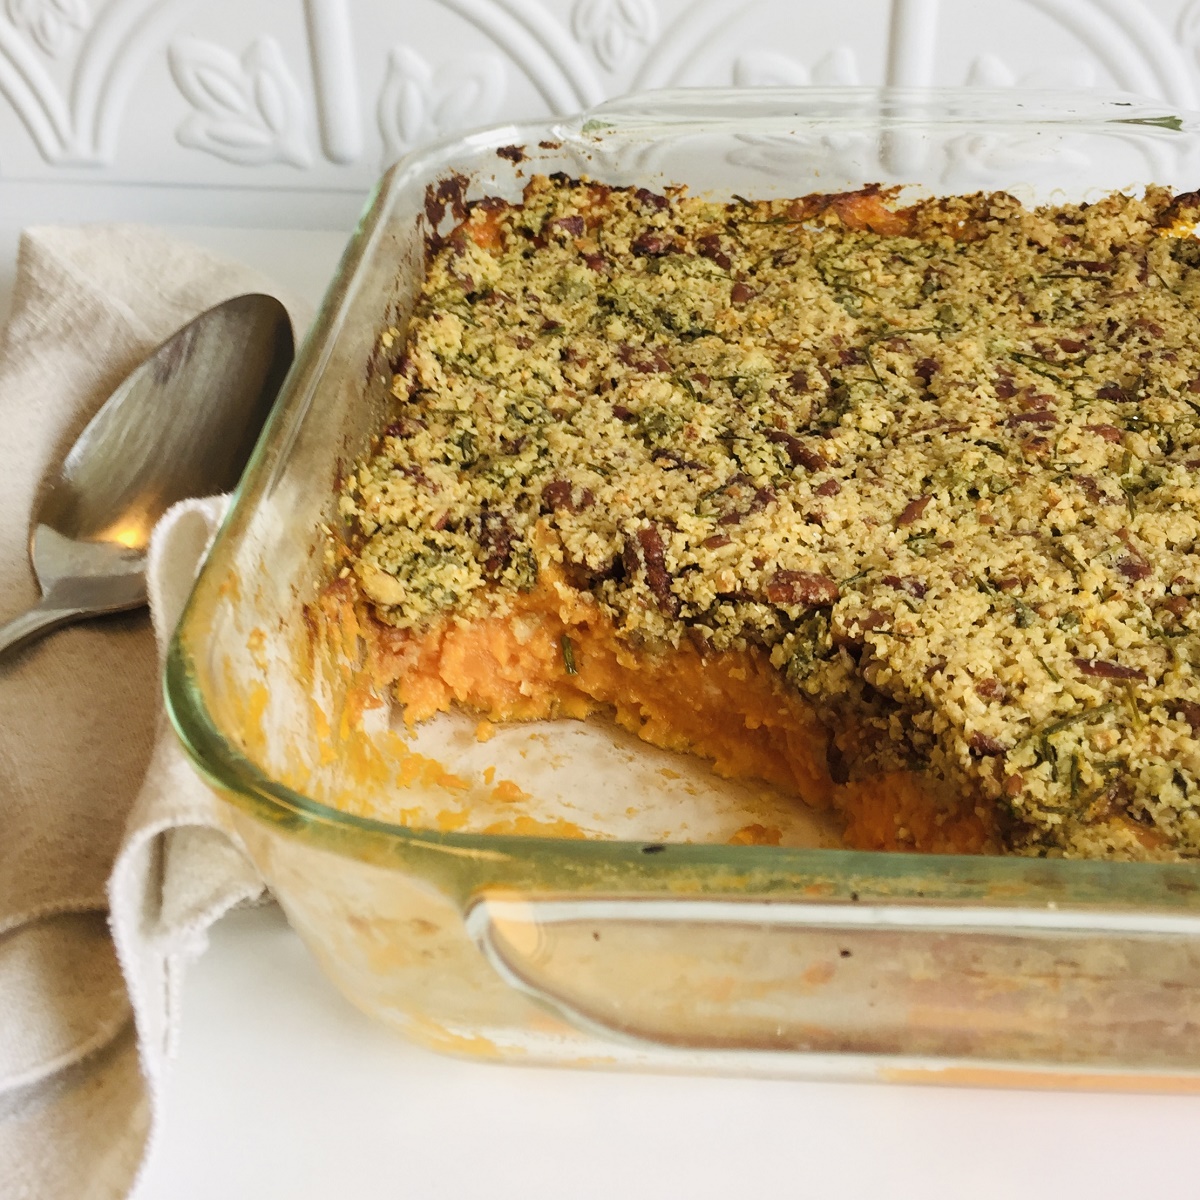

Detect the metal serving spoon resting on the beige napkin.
[{"left": 0, "top": 295, "right": 293, "bottom": 654}]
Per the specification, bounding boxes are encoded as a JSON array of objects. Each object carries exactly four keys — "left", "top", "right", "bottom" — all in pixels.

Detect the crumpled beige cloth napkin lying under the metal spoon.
[{"left": 0, "top": 226, "right": 306, "bottom": 1200}]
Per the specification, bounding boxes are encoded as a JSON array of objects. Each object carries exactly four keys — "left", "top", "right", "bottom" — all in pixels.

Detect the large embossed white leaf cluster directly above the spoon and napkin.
[{"left": 168, "top": 37, "right": 312, "bottom": 167}]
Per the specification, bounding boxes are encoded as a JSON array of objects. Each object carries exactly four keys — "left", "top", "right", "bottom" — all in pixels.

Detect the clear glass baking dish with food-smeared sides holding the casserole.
[{"left": 166, "top": 89, "right": 1200, "bottom": 1090}]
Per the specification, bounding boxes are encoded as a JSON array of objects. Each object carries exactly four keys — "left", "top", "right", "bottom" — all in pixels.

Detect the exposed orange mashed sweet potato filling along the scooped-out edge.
[{"left": 360, "top": 568, "right": 995, "bottom": 853}]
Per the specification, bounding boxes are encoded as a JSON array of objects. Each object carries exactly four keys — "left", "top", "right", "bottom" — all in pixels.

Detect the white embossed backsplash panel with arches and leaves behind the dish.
[{"left": 0, "top": 0, "right": 1200, "bottom": 214}]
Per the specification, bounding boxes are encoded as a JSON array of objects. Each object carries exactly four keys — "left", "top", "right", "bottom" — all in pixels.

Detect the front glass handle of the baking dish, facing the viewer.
[{"left": 466, "top": 894, "right": 1200, "bottom": 1073}]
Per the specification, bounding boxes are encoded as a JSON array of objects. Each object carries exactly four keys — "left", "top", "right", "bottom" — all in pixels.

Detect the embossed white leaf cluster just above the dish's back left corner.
[{"left": 377, "top": 46, "right": 505, "bottom": 162}]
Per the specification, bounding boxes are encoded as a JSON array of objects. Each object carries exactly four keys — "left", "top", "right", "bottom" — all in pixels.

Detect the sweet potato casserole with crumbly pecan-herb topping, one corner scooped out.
[{"left": 336, "top": 176, "right": 1200, "bottom": 858}]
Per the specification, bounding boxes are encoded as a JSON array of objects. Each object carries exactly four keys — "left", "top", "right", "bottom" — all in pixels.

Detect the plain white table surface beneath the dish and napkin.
[{"left": 7, "top": 199, "right": 1200, "bottom": 1200}]
